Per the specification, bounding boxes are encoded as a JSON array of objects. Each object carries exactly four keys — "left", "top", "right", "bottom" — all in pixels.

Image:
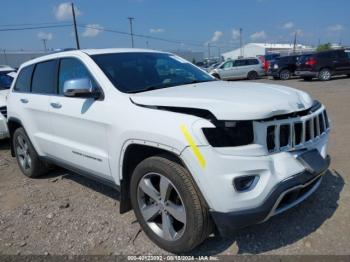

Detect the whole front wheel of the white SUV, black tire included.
[{"left": 130, "top": 156, "right": 213, "bottom": 254}]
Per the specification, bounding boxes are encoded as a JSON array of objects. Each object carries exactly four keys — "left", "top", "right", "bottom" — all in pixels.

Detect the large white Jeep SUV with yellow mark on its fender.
[{"left": 8, "top": 49, "right": 330, "bottom": 253}]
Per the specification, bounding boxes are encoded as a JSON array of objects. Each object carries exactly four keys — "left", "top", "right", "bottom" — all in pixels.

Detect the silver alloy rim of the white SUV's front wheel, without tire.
[{"left": 137, "top": 173, "right": 186, "bottom": 241}]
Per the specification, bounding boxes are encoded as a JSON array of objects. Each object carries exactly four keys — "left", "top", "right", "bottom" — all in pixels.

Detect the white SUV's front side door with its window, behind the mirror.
[{"left": 49, "top": 57, "right": 111, "bottom": 179}]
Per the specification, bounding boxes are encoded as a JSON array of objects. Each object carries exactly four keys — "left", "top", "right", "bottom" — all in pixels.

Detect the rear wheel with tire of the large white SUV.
[{"left": 12, "top": 127, "right": 49, "bottom": 178}]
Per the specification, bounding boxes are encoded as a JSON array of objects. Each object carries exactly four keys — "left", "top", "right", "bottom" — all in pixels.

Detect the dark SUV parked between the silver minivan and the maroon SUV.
[{"left": 268, "top": 55, "right": 301, "bottom": 80}]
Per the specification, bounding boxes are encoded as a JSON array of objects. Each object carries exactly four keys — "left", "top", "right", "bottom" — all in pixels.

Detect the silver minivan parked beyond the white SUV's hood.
[{"left": 210, "top": 58, "right": 265, "bottom": 80}]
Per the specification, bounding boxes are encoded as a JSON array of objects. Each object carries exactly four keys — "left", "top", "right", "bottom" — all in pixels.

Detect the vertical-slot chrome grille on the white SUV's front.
[{"left": 265, "top": 110, "right": 329, "bottom": 152}]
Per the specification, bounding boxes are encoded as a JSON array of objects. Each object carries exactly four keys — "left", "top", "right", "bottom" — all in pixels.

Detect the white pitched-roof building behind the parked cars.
[{"left": 222, "top": 43, "right": 314, "bottom": 60}]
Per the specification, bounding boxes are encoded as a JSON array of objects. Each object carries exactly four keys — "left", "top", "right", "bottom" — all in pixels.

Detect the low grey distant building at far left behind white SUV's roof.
[{"left": 0, "top": 50, "right": 46, "bottom": 68}]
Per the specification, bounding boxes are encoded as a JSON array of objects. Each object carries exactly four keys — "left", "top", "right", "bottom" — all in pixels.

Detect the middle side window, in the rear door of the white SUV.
[{"left": 32, "top": 60, "right": 57, "bottom": 94}]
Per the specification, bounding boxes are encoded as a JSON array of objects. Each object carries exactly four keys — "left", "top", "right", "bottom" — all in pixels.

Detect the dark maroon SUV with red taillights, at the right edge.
[{"left": 295, "top": 49, "right": 350, "bottom": 81}]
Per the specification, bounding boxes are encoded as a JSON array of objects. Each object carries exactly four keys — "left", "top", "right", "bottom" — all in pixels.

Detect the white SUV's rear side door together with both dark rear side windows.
[{"left": 12, "top": 60, "right": 57, "bottom": 156}]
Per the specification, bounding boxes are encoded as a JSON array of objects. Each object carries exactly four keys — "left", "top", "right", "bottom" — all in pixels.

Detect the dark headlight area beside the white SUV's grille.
[{"left": 202, "top": 121, "right": 254, "bottom": 147}]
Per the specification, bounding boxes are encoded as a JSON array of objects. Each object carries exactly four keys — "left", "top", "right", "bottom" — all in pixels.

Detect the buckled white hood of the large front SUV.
[{"left": 130, "top": 81, "right": 313, "bottom": 120}]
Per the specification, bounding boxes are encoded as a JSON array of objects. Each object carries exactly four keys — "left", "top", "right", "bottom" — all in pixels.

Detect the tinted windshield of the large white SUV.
[{"left": 92, "top": 52, "right": 215, "bottom": 93}]
